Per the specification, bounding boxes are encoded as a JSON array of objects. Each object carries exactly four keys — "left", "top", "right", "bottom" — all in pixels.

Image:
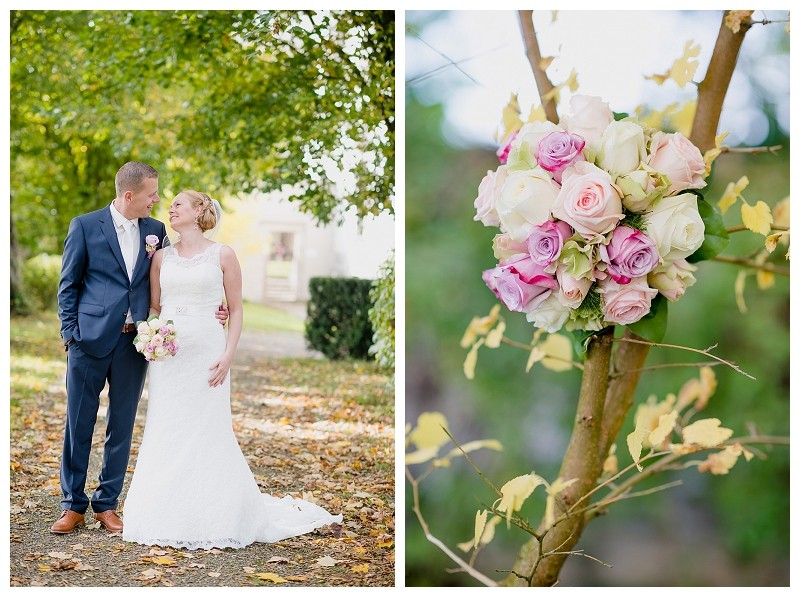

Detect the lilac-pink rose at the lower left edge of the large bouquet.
[{"left": 483, "top": 255, "right": 558, "bottom": 312}]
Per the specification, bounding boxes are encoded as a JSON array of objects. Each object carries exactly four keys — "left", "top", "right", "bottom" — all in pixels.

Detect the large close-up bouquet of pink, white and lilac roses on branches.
[{"left": 475, "top": 95, "right": 713, "bottom": 333}]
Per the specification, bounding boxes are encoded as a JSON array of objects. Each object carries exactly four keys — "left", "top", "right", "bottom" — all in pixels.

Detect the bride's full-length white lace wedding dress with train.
[{"left": 122, "top": 243, "right": 342, "bottom": 549}]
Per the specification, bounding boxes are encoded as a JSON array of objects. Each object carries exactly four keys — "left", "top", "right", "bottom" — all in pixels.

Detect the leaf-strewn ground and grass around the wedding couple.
[{"left": 10, "top": 316, "right": 395, "bottom": 587}]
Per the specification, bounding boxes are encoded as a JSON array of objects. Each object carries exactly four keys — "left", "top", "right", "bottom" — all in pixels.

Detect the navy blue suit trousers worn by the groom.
[{"left": 61, "top": 331, "right": 147, "bottom": 514}]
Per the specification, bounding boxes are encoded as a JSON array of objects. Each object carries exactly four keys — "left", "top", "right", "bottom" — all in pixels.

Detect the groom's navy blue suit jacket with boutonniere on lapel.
[{"left": 58, "top": 206, "right": 169, "bottom": 357}]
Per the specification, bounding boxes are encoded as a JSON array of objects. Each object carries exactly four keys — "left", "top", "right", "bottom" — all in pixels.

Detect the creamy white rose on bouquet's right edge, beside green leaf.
[{"left": 644, "top": 193, "right": 706, "bottom": 261}]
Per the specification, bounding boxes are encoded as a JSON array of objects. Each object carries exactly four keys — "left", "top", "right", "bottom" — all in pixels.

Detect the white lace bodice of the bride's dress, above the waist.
[{"left": 160, "top": 243, "right": 223, "bottom": 308}]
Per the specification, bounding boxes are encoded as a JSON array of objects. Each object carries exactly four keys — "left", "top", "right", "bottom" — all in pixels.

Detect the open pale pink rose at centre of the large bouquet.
[{"left": 553, "top": 162, "right": 625, "bottom": 240}]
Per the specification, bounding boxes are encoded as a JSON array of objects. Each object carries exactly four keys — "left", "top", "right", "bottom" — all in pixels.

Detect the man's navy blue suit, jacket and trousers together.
[{"left": 58, "top": 206, "right": 169, "bottom": 513}]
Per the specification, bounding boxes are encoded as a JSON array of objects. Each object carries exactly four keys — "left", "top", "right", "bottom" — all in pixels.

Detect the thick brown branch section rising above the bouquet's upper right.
[{"left": 690, "top": 11, "right": 753, "bottom": 152}]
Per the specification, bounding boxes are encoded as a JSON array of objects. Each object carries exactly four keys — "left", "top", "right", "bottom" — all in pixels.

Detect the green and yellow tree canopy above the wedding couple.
[{"left": 10, "top": 10, "right": 395, "bottom": 252}]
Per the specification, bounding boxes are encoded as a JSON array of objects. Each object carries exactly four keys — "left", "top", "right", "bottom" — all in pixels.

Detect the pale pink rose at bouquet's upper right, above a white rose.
[{"left": 647, "top": 131, "right": 706, "bottom": 195}]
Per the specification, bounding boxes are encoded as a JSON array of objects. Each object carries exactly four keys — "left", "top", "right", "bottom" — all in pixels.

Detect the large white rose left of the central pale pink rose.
[{"left": 495, "top": 167, "right": 558, "bottom": 242}]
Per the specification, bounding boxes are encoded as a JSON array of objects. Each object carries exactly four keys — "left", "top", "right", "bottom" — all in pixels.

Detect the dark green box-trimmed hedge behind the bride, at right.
[{"left": 305, "top": 277, "right": 373, "bottom": 360}]
